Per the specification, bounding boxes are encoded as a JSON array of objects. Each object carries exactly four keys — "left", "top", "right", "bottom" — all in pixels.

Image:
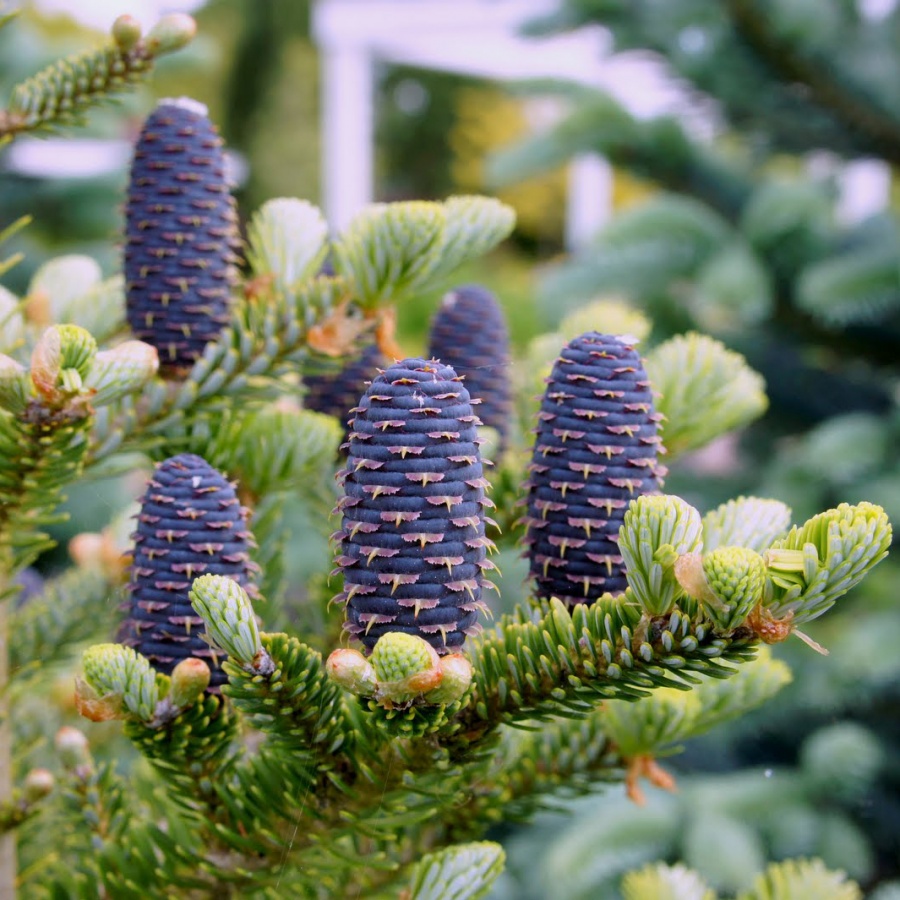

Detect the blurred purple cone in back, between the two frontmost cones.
[{"left": 428, "top": 284, "right": 512, "bottom": 445}]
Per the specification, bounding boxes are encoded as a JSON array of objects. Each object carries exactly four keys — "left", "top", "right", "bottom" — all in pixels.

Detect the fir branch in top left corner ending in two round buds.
[{"left": 0, "top": 14, "right": 196, "bottom": 138}]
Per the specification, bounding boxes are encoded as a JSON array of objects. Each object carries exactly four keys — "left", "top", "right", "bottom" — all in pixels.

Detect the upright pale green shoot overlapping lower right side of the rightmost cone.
[{"left": 619, "top": 494, "right": 702, "bottom": 616}]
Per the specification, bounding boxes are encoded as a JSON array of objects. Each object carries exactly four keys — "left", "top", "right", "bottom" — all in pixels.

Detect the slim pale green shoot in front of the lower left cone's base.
[{"left": 190, "top": 575, "right": 263, "bottom": 667}]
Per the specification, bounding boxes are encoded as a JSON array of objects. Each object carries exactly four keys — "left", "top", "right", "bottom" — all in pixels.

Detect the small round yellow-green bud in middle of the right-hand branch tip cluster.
[{"left": 699, "top": 547, "right": 766, "bottom": 631}]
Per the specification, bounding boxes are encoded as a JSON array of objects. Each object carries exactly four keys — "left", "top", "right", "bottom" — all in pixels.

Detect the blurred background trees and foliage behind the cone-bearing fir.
[{"left": 0, "top": 0, "right": 900, "bottom": 900}]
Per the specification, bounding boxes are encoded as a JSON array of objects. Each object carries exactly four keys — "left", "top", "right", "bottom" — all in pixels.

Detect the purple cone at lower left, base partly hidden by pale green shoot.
[{"left": 119, "top": 453, "right": 255, "bottom": 687}]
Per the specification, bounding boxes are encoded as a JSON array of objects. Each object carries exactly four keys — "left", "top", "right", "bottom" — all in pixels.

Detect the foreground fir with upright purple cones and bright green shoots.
[{"left": 0, "top": 7, "right": 892, "bottom": 900}]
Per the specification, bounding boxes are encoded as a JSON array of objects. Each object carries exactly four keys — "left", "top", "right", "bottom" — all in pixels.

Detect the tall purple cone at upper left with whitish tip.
[{"left": 125, "top": 99, "right": 239, "bottom": 370}]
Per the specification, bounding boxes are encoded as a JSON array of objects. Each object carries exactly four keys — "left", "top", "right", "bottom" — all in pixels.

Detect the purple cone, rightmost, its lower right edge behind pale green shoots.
[{"left": 524, "top": 332, "right": 665, "bottom": 606}]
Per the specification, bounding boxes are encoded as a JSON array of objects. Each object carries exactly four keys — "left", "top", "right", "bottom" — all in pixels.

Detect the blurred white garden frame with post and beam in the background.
[{"left": 313, "top": 0, "right": 890, "bottom": 249}]
